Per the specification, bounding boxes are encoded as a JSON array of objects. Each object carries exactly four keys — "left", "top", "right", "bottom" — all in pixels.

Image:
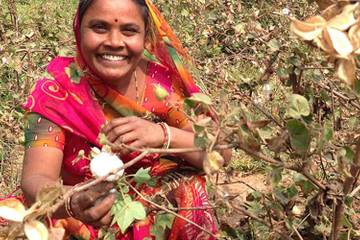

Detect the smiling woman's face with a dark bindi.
[{"left": 80, "top": 0, "right": 145, "bottom": 85}]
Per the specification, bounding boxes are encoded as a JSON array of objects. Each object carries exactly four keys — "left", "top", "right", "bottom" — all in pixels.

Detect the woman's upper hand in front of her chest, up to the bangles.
[{"left": 102, "top": 117, "right": 164, "bottom": 151}]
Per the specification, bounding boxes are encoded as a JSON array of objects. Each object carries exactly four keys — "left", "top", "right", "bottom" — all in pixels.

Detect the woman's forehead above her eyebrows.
[{"left": 83, "top": 0, "right": 144, "bottom": 24}]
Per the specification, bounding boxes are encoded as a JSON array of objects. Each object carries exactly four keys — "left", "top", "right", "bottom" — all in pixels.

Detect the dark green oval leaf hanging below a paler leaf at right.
[{"left": 286, "top": 119, "right": 311, "bottom": 155}]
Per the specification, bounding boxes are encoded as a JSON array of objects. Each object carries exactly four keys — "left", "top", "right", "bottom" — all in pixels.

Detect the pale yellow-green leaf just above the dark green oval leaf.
[{"left": 287, "top": 94, "right": 310, "bottom": 119}]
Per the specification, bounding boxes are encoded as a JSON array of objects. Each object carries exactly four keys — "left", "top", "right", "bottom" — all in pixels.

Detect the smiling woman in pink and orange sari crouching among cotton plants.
[{"left": 21, "top": 0, "right": 229, "bottom": 239}]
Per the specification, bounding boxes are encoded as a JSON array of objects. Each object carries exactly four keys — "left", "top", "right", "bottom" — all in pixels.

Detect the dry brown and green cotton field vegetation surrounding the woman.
[{"left": 0, "top": 0, "right": 360, "bottom": 240}]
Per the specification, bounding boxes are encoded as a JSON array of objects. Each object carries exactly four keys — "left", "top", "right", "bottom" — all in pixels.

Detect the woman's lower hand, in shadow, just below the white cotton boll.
[{"left": 70, "top": 183, "right": 115, "bottom": 227}]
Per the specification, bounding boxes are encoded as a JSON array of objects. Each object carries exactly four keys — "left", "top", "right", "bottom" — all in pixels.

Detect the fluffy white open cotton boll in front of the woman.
[{"left": 90, "top": 152, "right": 124, "bottom": 182}]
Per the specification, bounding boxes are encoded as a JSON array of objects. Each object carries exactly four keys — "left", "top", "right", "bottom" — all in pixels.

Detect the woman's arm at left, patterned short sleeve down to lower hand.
[{"left": 21, "top": 113, "right": 115, "bottom": 226}]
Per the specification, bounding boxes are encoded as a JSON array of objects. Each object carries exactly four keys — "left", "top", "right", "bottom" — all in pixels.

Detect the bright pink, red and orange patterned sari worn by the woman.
[{"left": 19, "top": 1, "right": 216, "bottom": 240}]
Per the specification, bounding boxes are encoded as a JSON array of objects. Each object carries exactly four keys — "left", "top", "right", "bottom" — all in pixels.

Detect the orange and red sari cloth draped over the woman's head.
[{"left": 73, "top": 0, "right": 200, "bottom": 96}]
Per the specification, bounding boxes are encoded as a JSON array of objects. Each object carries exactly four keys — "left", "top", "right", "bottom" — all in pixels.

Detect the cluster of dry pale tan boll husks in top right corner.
[{"left": 291, "top": 0, "right": 360, "bottom": 86}]
